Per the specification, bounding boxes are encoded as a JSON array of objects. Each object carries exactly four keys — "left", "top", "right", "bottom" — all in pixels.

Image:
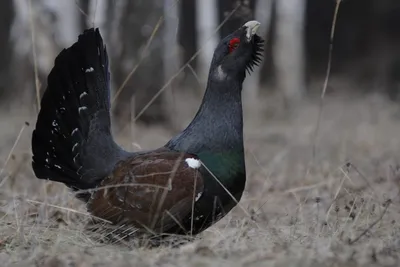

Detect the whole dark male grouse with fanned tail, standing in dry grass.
[{"left": 32, "top": 21, "right": 264, "bottom": 238}]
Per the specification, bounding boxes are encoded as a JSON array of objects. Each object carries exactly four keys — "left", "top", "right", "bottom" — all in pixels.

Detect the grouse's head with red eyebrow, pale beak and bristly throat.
[{"left": 210, "top": 20, "right": 264, "bottom": 80}]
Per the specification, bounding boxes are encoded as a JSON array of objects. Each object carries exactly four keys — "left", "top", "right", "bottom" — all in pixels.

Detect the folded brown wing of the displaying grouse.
[{"left": 88, "top": 150, "right": 203, "bottom": 232}]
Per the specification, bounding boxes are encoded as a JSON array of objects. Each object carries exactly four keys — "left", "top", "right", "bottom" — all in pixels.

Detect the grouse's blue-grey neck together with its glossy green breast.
[{"left": 166, "top": 74, "right": 246, "bottom": 189}]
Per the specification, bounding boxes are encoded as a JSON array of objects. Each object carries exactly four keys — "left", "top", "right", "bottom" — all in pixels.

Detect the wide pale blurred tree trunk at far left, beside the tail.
[{"left": 11, "top": 0, "right": 69, "bottom": 112}]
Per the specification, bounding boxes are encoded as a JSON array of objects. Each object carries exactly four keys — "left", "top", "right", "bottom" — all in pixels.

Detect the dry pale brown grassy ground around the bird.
[{"left": 0, "top": 91, "right": 400, "bottom": 267}]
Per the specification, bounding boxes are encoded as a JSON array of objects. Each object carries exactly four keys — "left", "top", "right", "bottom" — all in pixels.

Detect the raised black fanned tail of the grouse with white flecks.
[{"left": 32, "top": 29, "right": 128, "bottom": 199}]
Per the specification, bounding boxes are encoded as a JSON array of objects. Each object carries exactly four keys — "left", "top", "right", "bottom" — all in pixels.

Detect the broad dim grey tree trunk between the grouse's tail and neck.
[{"left": 113, "top": 0, "right": 167, "bottom": 124}]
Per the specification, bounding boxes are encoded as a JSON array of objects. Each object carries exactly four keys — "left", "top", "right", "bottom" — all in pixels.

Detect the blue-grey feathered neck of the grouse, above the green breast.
[{"left": 167, "top": 75, "right": 243, "bottom": 154}]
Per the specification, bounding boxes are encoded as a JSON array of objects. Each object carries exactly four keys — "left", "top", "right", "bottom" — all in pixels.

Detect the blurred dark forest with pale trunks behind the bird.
[{"left": 0, "top": 0, "right": 400, "bottom": 129}]
